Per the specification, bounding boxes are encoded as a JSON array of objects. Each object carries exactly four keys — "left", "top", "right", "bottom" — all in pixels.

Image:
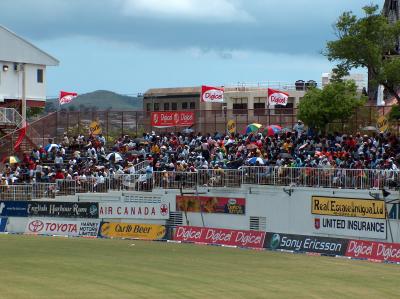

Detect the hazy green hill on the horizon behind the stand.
[{"left": 46, "top": 90, "right": 143, "bottom": 112}]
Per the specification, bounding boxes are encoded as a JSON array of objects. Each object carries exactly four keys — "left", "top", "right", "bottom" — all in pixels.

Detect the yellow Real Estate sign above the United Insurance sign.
[{"left": 311, "top": 196, "right": 386, "bottom": 219}]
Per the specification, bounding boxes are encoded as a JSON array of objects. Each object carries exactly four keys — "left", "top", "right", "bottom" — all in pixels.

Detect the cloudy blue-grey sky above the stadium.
[{"left": 0, "top": 0, "right": 384, "bottom": 96}]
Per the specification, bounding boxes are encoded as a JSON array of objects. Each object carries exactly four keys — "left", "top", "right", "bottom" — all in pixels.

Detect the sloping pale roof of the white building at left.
[{"left": 0, "top": 25, "right": 60, "bottom": 66}]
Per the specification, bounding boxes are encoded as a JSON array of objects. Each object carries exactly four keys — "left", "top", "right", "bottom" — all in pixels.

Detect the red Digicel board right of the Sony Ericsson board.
[{"left": 346, "top": 240, "right": 400, "bottom": 263}]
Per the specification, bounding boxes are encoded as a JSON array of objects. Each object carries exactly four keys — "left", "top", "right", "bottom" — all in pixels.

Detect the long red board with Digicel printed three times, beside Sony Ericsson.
[{"left": 174, "top": 226, "right": 265, "bottom": 248}]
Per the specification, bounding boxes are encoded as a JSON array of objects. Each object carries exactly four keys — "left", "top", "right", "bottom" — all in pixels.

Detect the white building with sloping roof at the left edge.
[{"left": 0, "top": 25, "right": 59, "bottom": 107}]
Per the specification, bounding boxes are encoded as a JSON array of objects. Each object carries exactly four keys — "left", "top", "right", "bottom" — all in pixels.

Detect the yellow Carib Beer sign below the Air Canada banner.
[{"left": 100, "top": 222, "right": 166, "bottom": 240}]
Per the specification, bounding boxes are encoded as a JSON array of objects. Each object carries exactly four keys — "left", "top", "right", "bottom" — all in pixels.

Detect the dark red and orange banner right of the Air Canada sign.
[{"left": 176, "top": 195, "right": 246, "bottom": 215}]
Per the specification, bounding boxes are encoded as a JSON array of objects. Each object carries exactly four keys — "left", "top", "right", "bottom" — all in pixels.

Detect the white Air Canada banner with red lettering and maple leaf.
[{"left": 99, "top": 202, "right": 169, "bottom": 219}]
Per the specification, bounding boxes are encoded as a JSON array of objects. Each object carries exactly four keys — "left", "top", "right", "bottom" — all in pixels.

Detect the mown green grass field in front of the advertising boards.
[{"left": 0, "top": 235, "right": 400, "bottom": 299}]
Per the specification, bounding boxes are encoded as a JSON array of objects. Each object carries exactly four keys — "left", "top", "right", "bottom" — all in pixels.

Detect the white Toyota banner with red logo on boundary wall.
[{"left": 25, "top": 218, "right": 100, "bottom": 237}]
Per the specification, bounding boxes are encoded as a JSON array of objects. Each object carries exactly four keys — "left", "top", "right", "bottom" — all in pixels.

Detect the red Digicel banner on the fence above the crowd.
[{"left": 151, "top": 111, "right": 195, "bottom": 128}]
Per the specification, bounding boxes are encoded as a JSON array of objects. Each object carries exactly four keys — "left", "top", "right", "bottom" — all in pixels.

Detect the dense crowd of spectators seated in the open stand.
[{"left": 1, "top": 121, "right": 400, "bottom": 185}]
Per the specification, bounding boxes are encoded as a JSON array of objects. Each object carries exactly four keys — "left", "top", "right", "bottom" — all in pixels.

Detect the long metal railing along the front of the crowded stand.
[{"left": 0, "top": 166, "right": 400, "bottom": 200}]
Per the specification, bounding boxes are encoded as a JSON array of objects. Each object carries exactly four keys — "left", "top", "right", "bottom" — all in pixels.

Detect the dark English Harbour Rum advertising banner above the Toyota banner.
[{"left": 27, "top": 201, "right": 99, "bottom": 218}]
